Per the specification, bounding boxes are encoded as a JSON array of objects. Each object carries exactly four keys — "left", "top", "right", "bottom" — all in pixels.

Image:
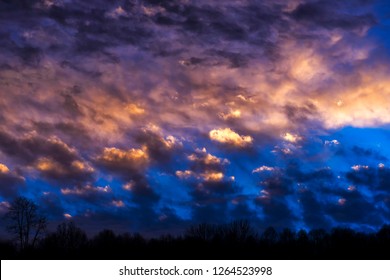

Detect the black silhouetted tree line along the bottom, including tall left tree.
[{"left": 0, "top": 198, "right": 390, "bottom": 259}]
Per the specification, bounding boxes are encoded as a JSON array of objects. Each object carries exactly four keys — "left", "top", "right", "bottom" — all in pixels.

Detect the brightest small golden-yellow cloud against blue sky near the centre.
[{"left": 209, "top": 128, "right": 253, "bottom": 147}]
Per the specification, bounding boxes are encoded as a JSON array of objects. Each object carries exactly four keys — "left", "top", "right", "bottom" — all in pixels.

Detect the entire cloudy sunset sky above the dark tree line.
[{"left": 0, "top": 0, "right": 390, "bottom": 235}]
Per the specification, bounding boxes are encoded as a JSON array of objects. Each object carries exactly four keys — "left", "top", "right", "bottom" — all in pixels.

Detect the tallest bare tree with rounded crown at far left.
[{"left": 5, "top": 197, "right": 47, "bottom": 250}]
